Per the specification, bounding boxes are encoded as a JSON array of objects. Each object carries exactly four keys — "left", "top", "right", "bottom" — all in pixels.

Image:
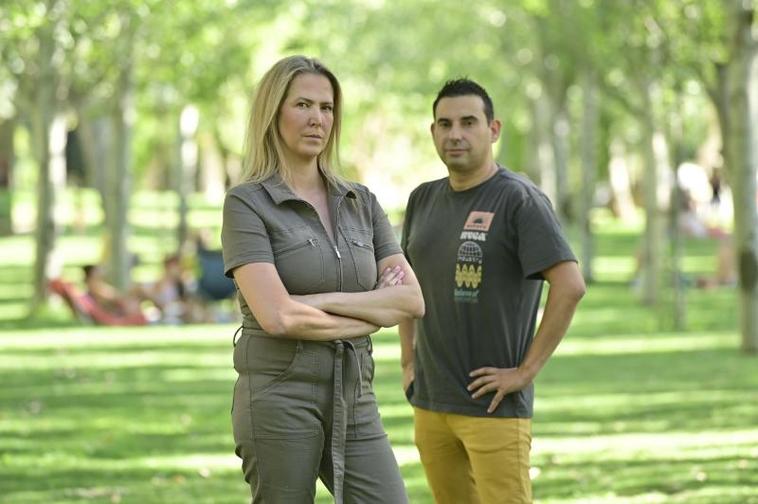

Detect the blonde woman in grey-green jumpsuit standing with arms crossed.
[{"left": 222, "top": 56, "right": 424, "bottom": 504}]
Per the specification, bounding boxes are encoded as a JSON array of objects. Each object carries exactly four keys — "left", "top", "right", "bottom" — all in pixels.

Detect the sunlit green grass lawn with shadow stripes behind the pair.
[{"left": 0, "top": 206, "right": 758, "bottom": 504}]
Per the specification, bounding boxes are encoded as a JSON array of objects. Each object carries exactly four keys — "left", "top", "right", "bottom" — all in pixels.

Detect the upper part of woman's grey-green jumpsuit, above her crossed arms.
[{"left": 221, "top": 175, "right": 402, "bottom": 336}]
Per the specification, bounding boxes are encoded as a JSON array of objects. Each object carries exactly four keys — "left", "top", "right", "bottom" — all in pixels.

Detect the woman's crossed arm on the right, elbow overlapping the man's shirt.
[{"left": 294, "top": 254, "right": 424, "bottom": 327}]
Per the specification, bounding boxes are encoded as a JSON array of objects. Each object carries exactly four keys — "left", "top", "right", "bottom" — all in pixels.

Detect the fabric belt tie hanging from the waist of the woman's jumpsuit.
[{"left": 332, "top": 340, "right": 363, "bottom": 504}]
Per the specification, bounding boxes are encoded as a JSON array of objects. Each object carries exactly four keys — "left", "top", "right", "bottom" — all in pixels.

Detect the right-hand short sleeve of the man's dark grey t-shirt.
[{"left": 515, "top": 193, "right": 576, "bottom": 279}]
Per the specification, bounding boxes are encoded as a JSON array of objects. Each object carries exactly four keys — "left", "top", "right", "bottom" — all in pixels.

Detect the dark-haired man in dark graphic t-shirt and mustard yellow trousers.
[{"left": 400, "top": 79, "right": 585, "bottom": 504}]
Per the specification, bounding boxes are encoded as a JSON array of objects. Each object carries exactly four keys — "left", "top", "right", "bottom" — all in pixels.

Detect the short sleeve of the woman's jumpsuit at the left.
[{"left": 221, "top": 192, "right": 274, "bottom": 278}]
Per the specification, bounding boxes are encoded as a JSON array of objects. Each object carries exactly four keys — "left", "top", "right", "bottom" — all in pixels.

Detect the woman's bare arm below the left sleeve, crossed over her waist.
[{"left": 234, "top": 263, "right": 379, "bottom": 341}]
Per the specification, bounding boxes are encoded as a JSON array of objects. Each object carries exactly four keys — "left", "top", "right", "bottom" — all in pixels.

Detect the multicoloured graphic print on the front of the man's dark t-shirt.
[{"left": 453, "top": 210, "right": 495, "bottom": 303}]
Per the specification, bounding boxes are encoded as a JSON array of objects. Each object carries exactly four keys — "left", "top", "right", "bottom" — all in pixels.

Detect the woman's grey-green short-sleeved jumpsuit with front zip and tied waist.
[{"left": 222, "top": 176, "right": 407, "bottom": 504}]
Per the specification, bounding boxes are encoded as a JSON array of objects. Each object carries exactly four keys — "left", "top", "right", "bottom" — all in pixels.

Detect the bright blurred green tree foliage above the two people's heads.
[{"left": 0, "top": 0, "right": 744, "bottom": 197}]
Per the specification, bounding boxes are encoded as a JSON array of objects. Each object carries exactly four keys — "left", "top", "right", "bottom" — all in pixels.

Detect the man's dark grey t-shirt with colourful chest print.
[{"left": 402, "top": 168, "right": 576, "bottom": 418}]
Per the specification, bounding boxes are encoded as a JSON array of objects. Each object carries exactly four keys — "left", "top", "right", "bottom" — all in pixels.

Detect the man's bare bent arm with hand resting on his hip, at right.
[{"left": 468, "top": 261, "right": 586, "bottom": 413}]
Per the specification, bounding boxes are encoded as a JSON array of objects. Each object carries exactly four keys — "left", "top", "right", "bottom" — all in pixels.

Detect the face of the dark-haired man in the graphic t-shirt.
[{"left": 432, "top": 95, "right": 500, "bottom": 173}]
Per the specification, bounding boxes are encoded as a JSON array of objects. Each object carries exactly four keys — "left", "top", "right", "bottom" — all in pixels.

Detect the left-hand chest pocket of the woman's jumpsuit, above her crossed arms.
[{"left": 271, "top": 226, "right": 324, "bottom": 294}]
